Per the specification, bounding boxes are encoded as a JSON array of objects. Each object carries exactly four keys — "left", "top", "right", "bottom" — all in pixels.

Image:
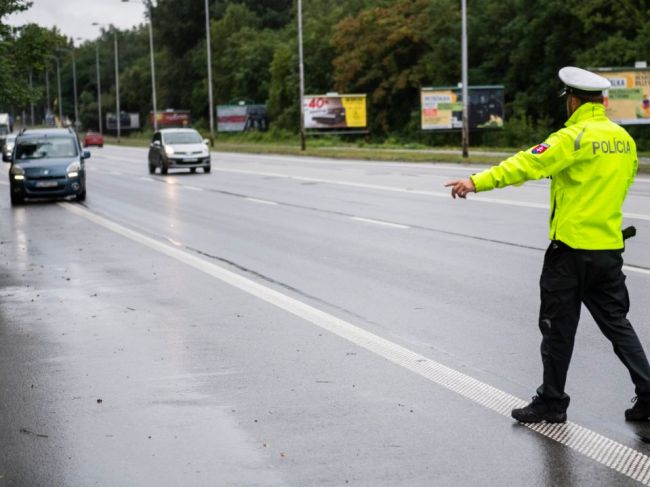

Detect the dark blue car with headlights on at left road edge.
[{"left": 3, "top": 129, "right": 90, "bottom": 205}]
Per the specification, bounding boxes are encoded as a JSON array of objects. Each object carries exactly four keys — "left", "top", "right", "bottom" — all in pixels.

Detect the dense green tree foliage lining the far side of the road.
[{"left": 6, "top": 0, "right": 650, "bottom": 148}]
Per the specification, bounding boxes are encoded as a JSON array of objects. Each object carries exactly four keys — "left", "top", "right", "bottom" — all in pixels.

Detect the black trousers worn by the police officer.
[{"left": 537, "top": 241, "right": 650, "bottom": 407}]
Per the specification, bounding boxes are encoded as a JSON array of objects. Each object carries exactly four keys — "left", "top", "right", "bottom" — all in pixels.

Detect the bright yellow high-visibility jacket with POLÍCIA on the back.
[{"left": 471, "top": 103, "right": 638, "bottom": 250}]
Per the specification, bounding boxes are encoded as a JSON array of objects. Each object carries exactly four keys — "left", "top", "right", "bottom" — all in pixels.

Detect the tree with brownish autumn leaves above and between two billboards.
[{"left": 331, "top": 0, "right": 460, "bottom": 134}]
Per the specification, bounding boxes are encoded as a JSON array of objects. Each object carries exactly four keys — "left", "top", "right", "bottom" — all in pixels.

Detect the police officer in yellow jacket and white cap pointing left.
[{"left": 446, "top": 67, "right": 650, "bottom": 423}]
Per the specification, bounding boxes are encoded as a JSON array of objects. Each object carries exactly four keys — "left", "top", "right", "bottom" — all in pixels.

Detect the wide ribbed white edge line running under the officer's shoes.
[{"left": 59, "top": 203, "right": 650, "bottom": 485}]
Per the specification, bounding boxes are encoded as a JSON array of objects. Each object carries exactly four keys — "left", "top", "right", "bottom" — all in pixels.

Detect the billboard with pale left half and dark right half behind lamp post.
[{"left": 420, "top": 86, "right": 505, "bottom": 130}]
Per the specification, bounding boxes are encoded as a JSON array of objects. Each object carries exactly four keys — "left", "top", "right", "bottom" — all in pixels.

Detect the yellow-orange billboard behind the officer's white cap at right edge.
[{"left": 595, "top": 68, "right": 650, "bottom": 125}]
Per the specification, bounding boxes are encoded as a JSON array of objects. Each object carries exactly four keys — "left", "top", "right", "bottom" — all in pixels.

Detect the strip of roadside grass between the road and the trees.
[{"left": 104, "top": 132, "right": 650, "bottom": 173}]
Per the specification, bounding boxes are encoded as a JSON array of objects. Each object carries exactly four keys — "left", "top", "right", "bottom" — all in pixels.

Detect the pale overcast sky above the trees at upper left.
[{"left": 6, "top": 0, "right": 145, "bottom": 40}]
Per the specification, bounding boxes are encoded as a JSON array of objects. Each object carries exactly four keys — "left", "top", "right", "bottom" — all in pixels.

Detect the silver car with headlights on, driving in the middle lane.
[{"left": 149, "top": 129, "right": 210, "bottom": 174}]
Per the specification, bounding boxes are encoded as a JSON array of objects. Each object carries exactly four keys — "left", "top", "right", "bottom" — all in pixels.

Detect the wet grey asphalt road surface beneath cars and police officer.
[{"left": 0, "top": 147, "right": 650, "bottom": 487}]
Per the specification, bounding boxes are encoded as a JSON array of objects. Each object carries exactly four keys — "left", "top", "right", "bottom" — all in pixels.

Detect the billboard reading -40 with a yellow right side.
[{"left": 303, "top": 94, "right": 367, "bottom": 129}]
